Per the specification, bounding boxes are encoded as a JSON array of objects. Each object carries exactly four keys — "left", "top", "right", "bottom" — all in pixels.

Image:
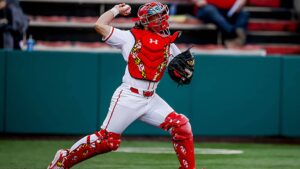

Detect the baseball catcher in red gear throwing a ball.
[{"left": 48, "top": 2, "right": 196, "bottom": 169}]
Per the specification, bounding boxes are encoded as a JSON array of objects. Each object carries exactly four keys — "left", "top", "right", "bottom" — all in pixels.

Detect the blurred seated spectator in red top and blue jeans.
[{"left": 192, "top": 0, "right": 249, "bottom": 48}]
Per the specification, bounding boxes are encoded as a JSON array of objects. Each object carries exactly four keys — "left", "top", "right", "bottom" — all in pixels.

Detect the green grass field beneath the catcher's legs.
[{"left": 0, "top": 140, "right": 300, "bottom": 169}]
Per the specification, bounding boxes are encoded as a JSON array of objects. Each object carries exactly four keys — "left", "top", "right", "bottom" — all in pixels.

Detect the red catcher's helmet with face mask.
[{"left": 137, "top": 2, "right": 170, "bottom": 35}]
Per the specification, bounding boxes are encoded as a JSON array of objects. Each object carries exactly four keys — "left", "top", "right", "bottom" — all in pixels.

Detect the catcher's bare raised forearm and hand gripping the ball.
[{"left": 95, "top": 3, "right": 131, "bottom": 38}]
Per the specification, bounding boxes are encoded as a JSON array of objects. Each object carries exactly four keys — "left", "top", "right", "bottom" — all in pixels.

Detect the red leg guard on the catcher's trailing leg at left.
[{"left": 63, "top": 130, "right": 121, "bottom": 168}]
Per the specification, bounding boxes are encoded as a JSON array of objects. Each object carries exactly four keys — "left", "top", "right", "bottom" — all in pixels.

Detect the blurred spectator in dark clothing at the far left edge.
[{"left": 0, "top": 0, "right": 28, "bottom": 49}]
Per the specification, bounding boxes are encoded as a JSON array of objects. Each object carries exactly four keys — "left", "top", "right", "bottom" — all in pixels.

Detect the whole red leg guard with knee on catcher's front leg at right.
[{"left": 160, "top": 112, "right": 196, "bottom": 169}]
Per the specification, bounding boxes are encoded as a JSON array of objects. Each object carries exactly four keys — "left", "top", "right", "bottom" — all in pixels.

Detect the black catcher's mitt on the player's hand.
[{"left": 168, "top": 49, "right": 195, "bottom": 85}]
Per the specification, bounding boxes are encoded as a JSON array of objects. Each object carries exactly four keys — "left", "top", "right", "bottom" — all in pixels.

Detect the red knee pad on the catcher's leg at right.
[{"left": 160, "top": 112, "right": 193, "bottom": 140}]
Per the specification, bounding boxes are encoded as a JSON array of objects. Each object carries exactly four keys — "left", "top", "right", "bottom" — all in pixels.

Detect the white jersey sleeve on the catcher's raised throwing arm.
[{"left": 102, "top": 27, "right": 132, "bottom": 49}]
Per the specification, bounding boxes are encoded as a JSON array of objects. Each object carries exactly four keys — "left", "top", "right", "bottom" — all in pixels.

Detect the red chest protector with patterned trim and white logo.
[{"left": 128, "top": 28, "right": 179, "bottom": 82}]
